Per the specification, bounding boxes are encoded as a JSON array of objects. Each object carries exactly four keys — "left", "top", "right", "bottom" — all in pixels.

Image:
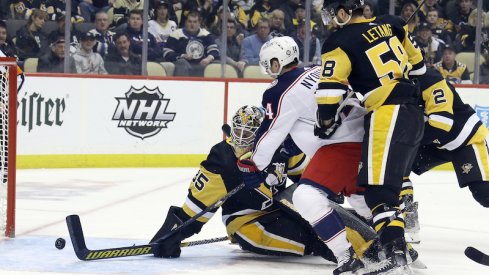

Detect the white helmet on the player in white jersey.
[{"left": 260, "top": 36, "right": 299, "bottom": 77}]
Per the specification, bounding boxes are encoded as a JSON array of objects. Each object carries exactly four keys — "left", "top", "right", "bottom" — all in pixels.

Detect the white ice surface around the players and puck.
[{"left": 0, "top": 168, "right": 489, "bottom": 275}]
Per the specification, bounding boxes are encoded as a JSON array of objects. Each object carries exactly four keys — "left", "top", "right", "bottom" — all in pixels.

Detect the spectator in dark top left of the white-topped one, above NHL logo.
[{"left": 126, "top": 10, "right": 162, "bottom": 61}]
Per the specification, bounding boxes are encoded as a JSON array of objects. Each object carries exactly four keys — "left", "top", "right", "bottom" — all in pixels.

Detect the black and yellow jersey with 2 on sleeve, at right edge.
[{"left": 418, "top": 68, "right": 489, "bottom": 151}]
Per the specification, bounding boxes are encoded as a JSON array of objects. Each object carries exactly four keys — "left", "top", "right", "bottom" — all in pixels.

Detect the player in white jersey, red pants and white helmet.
[{"left": 238, "top": 37, "right": 371, "bottom": 274}]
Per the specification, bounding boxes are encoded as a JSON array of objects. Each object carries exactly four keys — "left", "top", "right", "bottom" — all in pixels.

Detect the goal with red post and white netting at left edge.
[{"left": 0, "top": 58, "right": 17, "bottom": 238}]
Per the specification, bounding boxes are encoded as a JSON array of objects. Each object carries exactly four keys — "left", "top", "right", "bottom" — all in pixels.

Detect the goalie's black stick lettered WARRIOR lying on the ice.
[{"left": 66, "top": 215, "right": 228, "bottom": 261}]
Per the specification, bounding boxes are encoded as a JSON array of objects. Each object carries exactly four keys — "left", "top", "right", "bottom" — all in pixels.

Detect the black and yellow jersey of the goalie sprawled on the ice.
[{"left": 182, "top": 139, "right": 307, "bottom": 236}]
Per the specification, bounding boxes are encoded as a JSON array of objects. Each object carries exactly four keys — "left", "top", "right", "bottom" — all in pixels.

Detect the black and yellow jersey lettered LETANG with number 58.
[{"left": 316, "top": 15, "right": 425, "bottom": 117}]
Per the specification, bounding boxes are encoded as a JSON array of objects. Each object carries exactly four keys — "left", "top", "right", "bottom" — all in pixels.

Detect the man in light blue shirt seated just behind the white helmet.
[{"left": 241, "top": 18, "right": 272, "bottom": 65}]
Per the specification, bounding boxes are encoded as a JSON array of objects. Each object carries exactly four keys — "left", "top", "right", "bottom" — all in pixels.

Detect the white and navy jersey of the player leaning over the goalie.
[{"left": 252, "top": 66, "right": 366, "bottom": 170}]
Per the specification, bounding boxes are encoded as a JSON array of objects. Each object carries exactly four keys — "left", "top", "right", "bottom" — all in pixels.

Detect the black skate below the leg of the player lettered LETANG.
[{"left": 364, "top": 239, "right": 412, "bottom": 275}]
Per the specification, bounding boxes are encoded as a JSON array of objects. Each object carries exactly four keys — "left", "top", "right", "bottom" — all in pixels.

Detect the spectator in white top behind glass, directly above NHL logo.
[{"left": 148, "top": 0, "right": 177, "bottom": 48}]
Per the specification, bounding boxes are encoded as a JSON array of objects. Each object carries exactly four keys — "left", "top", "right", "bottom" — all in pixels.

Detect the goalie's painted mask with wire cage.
[{"left": 231, "top": 105, "right": 263, "bottom": 157}]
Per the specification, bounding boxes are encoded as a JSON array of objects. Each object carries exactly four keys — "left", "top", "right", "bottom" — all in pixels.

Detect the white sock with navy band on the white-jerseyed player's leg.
[{"left": 292, "top": 184, "right": 351, "bottom": 256}]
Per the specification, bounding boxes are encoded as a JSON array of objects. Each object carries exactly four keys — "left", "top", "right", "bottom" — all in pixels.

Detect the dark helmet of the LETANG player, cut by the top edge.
[{"left": 321, "top": 0, "right": 365, "bottom": 26}]
